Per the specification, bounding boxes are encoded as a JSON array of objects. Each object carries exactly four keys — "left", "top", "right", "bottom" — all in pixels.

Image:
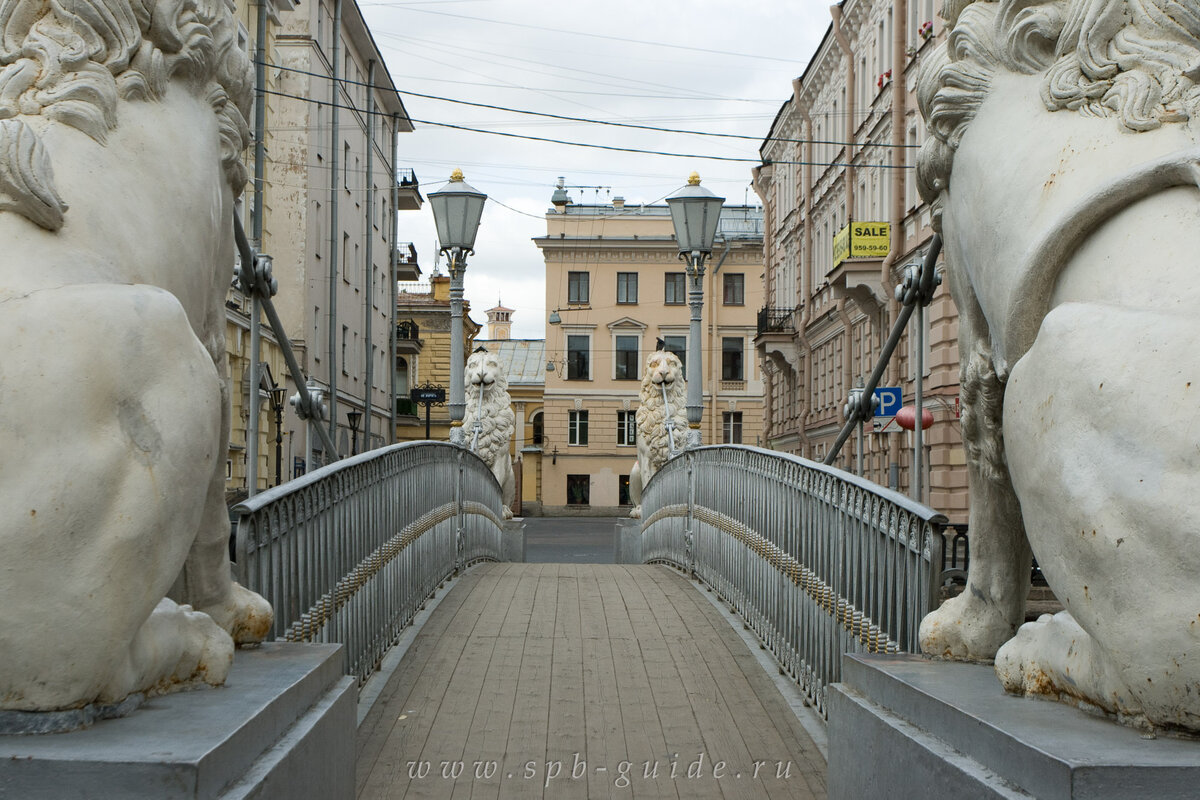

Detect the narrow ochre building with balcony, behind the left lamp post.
[{"left": 395, "top": 275, "right": 480, "bottom": 441}]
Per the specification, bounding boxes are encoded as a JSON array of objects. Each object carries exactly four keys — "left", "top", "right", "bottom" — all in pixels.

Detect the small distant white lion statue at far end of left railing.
[{"left": 462, "top": 348, "right": 516, "bottom": 519}]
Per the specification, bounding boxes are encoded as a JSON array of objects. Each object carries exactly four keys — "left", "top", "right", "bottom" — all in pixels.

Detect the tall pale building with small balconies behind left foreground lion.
[{"left": 262, "top": 0, "right": 422, "bottom": 473}]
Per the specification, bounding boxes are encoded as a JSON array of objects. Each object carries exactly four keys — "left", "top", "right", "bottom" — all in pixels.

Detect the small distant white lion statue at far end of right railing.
[{"left": 629, "top": 350, "right": 688, "bottom": 519}]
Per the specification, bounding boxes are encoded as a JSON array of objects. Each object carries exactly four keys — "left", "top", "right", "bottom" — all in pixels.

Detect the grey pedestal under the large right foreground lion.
[{"left": 828, "top": 655, "right": 1200, "bottom": 800}]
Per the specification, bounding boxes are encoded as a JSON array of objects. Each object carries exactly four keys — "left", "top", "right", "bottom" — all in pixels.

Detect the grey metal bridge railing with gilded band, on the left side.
[{"left": 234, "top": 441, "right": 503, "bottom": 682}]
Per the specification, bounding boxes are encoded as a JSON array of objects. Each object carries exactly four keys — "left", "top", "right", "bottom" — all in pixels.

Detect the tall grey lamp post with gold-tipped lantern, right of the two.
[{"left": 667, "top": 173, "right": 725, "bottom": 447}]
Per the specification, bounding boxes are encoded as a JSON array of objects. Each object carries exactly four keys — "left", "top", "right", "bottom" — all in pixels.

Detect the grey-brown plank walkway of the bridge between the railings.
[{"left": 358, "top": 564, "right": 826, "bottom": 799}]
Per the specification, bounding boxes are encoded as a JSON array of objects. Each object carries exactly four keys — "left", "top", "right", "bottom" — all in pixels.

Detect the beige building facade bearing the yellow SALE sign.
[{"left": 754, "top": 0, "right": 967, "bottom": 523}]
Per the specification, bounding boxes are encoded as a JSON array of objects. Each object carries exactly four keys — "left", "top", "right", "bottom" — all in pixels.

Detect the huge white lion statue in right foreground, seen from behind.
[{"left": 918, "top": 0, "right": 1200, "bottom": 730}]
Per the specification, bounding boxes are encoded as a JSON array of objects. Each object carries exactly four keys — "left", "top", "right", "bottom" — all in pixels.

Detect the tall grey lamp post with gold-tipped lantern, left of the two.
[{"left": 428, "top": 169, "right": 487, "bottom": 445}]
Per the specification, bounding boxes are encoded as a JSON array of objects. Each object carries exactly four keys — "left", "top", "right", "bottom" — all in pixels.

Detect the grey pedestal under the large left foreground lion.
[{"left": 0, "top": 643, "right": 356, "bottom": 800}]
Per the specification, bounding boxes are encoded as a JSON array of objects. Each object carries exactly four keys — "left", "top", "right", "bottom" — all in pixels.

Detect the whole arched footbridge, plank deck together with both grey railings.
[{"left": 236, "top": 443, "right": 944, "bottom": 798}]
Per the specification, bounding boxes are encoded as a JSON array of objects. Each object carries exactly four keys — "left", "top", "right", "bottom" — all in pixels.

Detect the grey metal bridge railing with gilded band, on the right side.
[{"left": 642, "top": 445, "right": 946, "bottom": 715}]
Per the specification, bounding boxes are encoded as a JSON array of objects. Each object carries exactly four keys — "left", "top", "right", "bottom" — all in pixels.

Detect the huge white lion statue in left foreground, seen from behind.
[{"left": 0, "top": 0, "right": 271, "bottom": 711}]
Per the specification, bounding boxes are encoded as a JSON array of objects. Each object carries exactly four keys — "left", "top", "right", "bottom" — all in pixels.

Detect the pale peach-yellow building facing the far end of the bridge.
[{"left": 534, "top": 189, "right": 763, "bottom": 515}]
